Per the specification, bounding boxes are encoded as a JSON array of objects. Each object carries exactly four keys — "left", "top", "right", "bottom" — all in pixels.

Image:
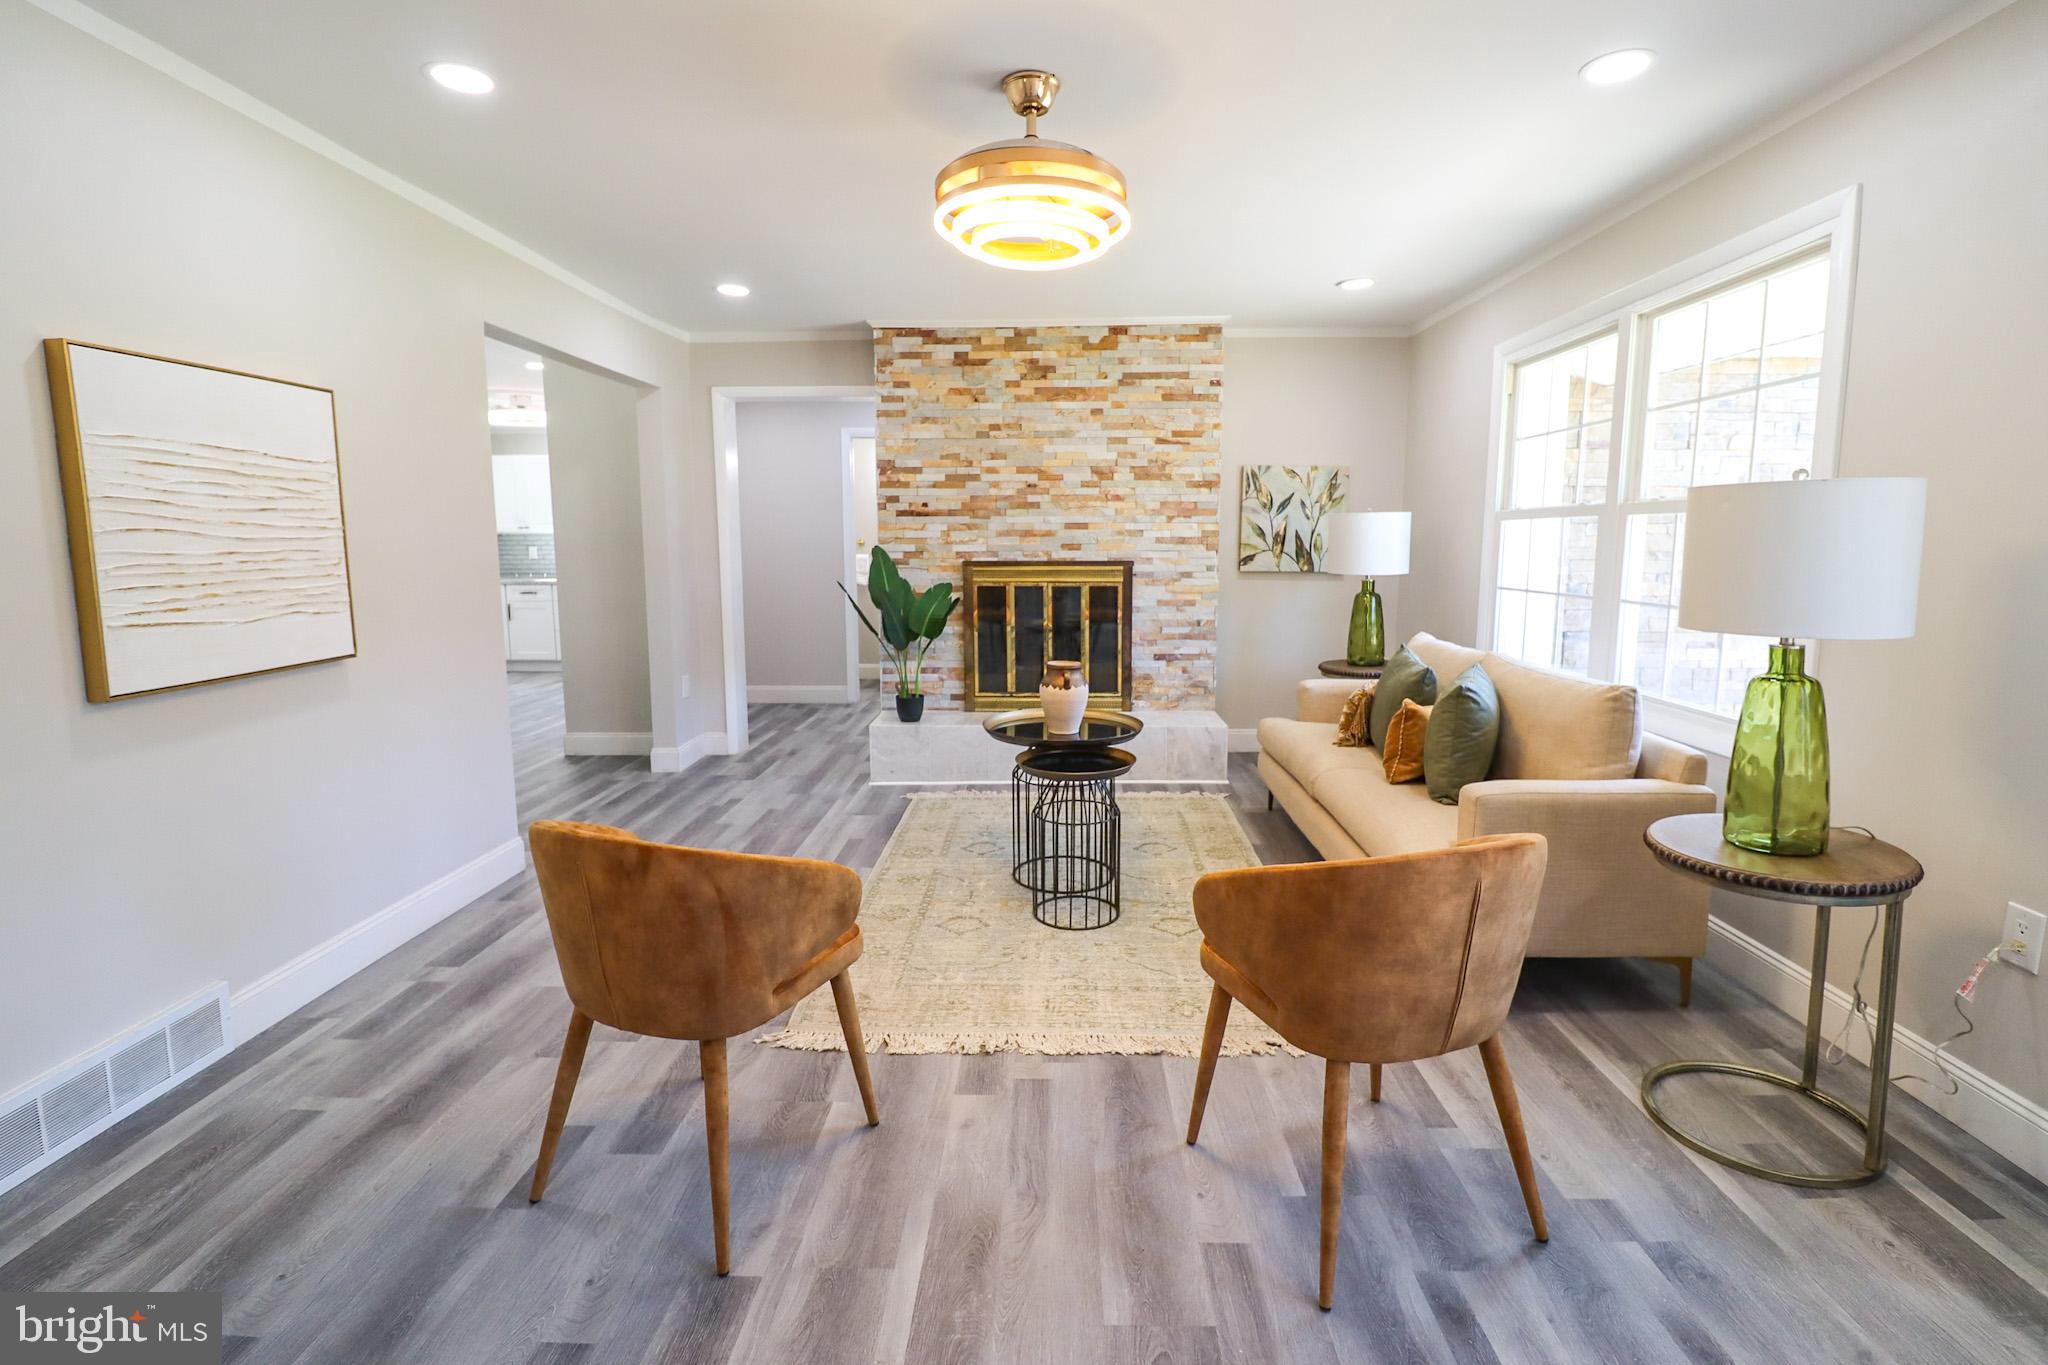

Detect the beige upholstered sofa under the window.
[{"left": 1260, "top": 634, "right": 1714, "bottom": 999}]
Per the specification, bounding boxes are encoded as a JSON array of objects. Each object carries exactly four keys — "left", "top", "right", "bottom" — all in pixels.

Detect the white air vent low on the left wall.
[{"left": 0, "top": 982, "right": 227, "bottom": 1193}]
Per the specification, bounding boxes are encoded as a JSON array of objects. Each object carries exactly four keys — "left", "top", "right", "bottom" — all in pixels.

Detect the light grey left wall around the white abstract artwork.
[{"left": 0, "top": 4, "right": 711, "bottom": 1093}]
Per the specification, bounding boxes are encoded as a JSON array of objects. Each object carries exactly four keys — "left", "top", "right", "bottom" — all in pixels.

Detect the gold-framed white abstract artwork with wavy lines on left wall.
[{"left": 43, "top": 340, "right": 356, "bottom": 702}]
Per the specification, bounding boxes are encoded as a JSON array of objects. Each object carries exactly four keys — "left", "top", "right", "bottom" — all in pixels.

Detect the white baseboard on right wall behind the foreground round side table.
[{"left": 1706, "top": 917, "right": 2048, "bottom": 1181}]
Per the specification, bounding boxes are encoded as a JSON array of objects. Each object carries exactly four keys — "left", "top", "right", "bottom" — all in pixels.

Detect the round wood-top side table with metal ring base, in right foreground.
[{"left": 1642, "top": 812, "right": 1925, "bottom": 1189}]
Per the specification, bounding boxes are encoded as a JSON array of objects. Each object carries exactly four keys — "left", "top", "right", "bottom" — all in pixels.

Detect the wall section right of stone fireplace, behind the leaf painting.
[{"left": 1217, "top": 334, "right": 1409, "bottom": 743}]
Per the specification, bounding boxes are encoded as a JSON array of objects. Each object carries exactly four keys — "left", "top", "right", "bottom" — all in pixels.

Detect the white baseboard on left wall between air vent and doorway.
[{"left": 227, "top": 839, "right": 526, "bottom": 1048}]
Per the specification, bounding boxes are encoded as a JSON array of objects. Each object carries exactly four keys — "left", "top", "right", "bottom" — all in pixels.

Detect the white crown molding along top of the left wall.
[{"left": 29, "top": 0, "right": 692, "bottom": 342}]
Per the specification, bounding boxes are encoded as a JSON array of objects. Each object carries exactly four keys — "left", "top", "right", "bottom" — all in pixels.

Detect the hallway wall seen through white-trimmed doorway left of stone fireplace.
[{"left": 739, "top": 401, "right": 874, "bottom": 702}]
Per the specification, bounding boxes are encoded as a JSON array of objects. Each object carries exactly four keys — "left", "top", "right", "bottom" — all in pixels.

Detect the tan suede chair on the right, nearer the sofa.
[{"left": 1188, "top": 835, "right": 1550, "bottom": 1308}]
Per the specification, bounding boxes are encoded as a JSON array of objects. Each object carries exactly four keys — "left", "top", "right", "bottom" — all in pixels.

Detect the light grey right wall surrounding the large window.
[{"left": 1401, "top": 2, "right": 2048, "bottom": 1103}]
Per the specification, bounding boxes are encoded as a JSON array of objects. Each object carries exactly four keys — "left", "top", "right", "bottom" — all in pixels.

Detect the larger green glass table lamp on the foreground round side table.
[{"left": 1677, "top": 479, "right": 1927, "bottom": 855}]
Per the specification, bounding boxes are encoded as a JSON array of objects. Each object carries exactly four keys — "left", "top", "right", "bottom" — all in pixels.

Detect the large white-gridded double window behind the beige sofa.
[{"left": 1481, "top": 194, "right": 1853, "bottom": 743}]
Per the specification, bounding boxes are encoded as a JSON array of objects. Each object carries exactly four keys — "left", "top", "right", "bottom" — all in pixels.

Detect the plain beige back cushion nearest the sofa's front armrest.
[{"left": 1487, "top": 655, "right": 1642, "bottom": 782}]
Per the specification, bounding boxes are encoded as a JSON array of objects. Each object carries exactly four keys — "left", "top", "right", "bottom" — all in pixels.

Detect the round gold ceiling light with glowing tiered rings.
[{"left": 932, "top": 72, "right": 1130, "bottom": 270}]
